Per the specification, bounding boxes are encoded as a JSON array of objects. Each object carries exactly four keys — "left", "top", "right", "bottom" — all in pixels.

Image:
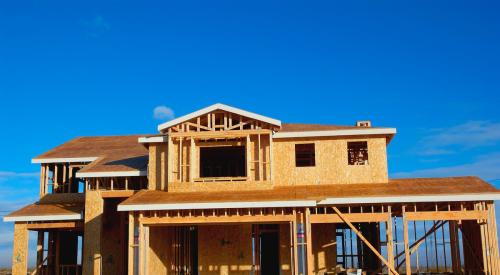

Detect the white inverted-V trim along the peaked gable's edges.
[{"left": 158, "top": 103, "right": 281, "bottom": 132}]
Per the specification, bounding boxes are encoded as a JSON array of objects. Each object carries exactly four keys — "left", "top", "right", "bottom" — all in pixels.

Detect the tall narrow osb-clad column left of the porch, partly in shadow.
[{"left": 82, "top": 191, "right": 104, "bottom": 275}]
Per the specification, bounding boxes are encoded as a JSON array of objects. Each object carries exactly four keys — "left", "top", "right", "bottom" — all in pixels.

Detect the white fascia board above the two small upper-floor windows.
[{"left": 273, "top": 128, "right": 396, "bottom": 139}]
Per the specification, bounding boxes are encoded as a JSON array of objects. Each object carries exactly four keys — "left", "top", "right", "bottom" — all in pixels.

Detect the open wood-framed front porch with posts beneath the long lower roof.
[{"left": 128, "top": 201, "right": 499, "bottom": 274}]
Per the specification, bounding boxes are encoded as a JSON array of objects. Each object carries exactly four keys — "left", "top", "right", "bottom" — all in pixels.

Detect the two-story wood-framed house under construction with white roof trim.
[{"left": 4, "top": 104, "right": 500, "bottom": 275}]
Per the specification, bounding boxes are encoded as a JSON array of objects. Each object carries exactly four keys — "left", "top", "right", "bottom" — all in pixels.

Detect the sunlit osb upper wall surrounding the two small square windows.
[{"left": 273, "top": 137, "right": 388, "bottom": 186}]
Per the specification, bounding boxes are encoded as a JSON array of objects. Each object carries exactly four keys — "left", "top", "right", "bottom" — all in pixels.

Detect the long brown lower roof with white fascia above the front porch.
[{"left": 118, "top": 177, "right": 500, "bottom": 211}]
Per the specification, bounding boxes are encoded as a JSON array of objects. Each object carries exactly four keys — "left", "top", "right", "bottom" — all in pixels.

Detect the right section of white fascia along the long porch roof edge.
[{"left": 318, "top": 193, "right": 500, "bottom": 206}]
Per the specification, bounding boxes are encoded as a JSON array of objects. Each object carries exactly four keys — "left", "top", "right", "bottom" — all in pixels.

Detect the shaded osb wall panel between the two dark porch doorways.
[{"left": 198, "top": 224, "right": 252, "bottom": 275}]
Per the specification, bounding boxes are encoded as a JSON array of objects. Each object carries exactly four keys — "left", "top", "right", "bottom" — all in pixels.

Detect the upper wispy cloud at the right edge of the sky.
[{"left": 418, "top": 121, "right": 500, "bottom": 156}]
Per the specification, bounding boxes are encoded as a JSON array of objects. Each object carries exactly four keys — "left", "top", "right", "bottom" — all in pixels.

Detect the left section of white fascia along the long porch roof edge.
[{"left": 118, "top": 200, "right": 316, "bottom": 211}]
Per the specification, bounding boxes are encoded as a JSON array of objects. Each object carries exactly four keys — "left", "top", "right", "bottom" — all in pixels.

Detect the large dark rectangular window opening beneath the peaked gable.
[{"left": 200, "top": 146, "right": 246, "bottom": 178}]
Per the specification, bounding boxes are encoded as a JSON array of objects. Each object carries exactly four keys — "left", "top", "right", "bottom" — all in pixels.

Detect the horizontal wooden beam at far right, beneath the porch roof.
[{"left": 406, "top": 210, "right": 488, "bottom": 221}]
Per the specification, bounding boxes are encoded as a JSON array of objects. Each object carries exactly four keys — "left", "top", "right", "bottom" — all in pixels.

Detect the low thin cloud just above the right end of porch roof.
[{"left": 391, "top": 153, "right": 500, "bottom": 181}]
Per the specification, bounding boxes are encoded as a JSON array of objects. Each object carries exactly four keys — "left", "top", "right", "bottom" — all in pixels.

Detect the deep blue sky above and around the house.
[{"left": 0, "top": 1, "right": 500, "bottom": 266}]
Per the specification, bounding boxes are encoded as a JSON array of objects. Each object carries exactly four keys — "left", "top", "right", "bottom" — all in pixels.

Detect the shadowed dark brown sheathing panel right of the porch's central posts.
[{"left": 311, "top": 224, "right": 337, "bottom": 274}]
